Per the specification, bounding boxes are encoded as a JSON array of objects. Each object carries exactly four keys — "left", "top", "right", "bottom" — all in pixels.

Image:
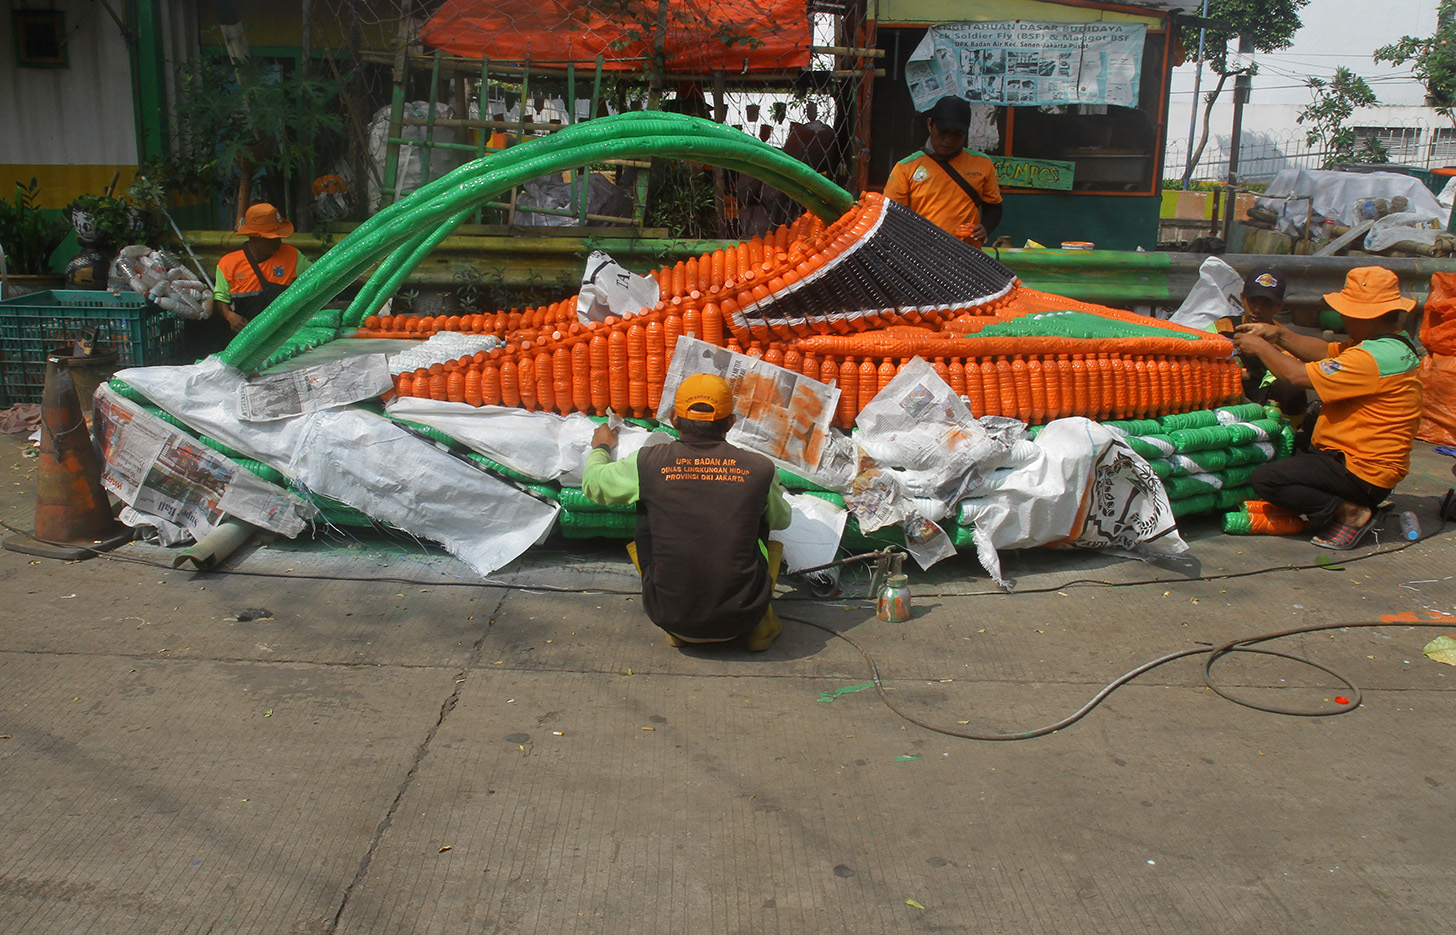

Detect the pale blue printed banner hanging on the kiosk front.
[{"left": 906, "top": 20, "right": 1147, "bottom": 112}]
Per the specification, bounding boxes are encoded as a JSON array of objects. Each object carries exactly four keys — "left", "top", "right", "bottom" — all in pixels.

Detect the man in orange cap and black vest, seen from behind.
[{"left": 581, "top": 373, "right": 789, "bottom": 652}]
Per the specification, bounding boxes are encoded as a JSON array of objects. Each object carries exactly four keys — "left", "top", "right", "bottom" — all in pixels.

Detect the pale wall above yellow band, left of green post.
[{"left": 0, "top": 0, "right": 137, "bottom": 165}]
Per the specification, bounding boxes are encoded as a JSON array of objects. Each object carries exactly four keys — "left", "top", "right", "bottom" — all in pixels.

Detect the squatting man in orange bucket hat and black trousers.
[{"left": 1233, "top": 267, "right": 1421, "bottom": 549}]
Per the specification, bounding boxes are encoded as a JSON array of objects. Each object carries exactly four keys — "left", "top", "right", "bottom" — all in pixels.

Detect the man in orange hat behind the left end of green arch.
[{"left": 213, "top": 202, "right": 309, "bottom": 334}]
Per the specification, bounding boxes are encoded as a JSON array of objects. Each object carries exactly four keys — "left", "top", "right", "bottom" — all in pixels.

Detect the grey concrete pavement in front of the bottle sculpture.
[{"left": 0, "top": 437, "right": 1456, "bottom": 935}]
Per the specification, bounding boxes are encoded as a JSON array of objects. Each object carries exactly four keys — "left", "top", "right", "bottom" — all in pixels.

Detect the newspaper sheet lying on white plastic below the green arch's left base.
[{"left": 237, "top": 354, "right": 393, "bottom": 422}]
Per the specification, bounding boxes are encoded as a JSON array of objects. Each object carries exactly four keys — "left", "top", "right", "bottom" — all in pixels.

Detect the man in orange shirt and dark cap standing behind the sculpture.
[{"left": 885, "top": 98, "right": 1002, "bottom": 246}]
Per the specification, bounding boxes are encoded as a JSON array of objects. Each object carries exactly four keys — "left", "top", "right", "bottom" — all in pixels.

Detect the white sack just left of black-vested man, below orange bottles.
[{"left": 387, "top": 396, "right": 673, "bottom": 486}]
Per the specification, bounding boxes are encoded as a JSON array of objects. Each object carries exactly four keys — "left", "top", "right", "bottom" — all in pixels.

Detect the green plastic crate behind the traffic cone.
[{"left": 0, "top": 290, "right": 183, "bottom": 402}]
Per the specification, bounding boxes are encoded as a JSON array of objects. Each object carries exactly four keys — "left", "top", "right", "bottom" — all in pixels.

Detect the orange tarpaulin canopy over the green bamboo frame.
[{"left": 421, "top": 0, "right": 810, "bottom": 73}]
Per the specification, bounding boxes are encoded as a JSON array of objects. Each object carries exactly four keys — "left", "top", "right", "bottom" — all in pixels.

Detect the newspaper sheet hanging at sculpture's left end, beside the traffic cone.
[{"left": 93, "top": 386, "right": 313, "bottom": 539}]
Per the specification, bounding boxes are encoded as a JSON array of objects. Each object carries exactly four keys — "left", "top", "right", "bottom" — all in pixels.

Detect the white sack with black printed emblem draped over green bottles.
[{"left": 958, "top": 418, "right": 1188, "bottom": 588}]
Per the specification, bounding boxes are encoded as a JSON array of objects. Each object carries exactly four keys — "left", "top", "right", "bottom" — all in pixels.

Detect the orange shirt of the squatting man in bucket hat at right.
[{"left": 1305, "top": 335, "right": 1421, "bottom": 488}]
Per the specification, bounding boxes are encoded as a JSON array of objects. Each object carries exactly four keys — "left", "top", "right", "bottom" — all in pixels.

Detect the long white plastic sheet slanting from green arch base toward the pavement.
[{"left": 116, "top": 357, "right": 558, "bottom": 575}]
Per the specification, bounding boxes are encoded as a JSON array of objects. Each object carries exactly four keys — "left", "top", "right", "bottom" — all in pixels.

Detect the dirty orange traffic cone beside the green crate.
[{"left": 3, "top": 357, "right": 131, "bottom": 561}]
